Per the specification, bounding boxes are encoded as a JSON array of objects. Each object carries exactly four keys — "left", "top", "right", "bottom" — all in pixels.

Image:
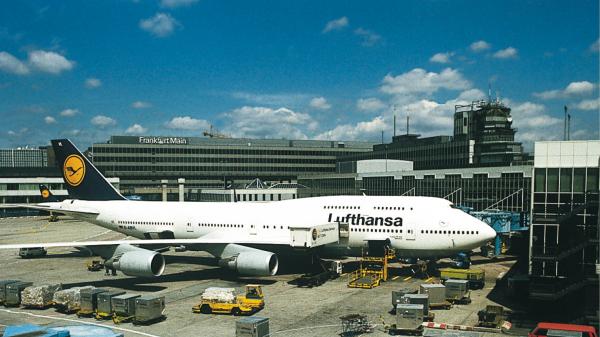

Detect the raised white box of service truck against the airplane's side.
[{"left": 290, "top": 222, "right": 343, "bottom": 248}]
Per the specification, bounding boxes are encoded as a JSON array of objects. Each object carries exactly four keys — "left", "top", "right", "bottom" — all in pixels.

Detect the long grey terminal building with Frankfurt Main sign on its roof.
[{"left": 87, "top": 136, "right": 373, "bottom": 200}]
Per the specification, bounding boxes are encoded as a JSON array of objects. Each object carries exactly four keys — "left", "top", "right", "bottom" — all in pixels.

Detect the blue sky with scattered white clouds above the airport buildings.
[{"left": 0, "top": 0, "right": 600, "bottom": 147}]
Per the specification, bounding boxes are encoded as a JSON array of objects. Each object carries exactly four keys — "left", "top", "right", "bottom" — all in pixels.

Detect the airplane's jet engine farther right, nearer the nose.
[{"left": 219, "top": 245, "right": 279, "bottom": 276}]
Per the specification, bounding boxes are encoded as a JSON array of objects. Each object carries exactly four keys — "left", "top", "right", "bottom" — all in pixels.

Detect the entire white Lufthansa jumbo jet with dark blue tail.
[{"left": 0, "top": 139, "right": 496, "bottom": 276}]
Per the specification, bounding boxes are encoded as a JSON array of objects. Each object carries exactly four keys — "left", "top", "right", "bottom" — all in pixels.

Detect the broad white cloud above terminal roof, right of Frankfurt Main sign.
[{"left": 224, "top": 106, "right": 318, "bottom": 139}]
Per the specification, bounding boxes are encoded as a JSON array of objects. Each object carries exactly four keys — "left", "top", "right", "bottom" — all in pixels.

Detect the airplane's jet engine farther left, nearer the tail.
[{"left": 106, "top": 245, "right": 165, "bottom": 277}]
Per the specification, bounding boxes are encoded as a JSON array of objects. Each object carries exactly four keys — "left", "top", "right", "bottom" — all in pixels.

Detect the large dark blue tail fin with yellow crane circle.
[{"left": 52, "top": 139, "right": 125, "bottom": 200}]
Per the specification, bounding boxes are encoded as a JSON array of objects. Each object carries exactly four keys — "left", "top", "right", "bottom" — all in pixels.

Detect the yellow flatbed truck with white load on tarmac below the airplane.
[{"left": 192, "top": 284, "right": 265, "bottom": 315}]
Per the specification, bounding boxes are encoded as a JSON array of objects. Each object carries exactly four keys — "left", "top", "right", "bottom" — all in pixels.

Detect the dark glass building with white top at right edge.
[{"left": 529, "top": 141, "right": 600, "bottom": 323}]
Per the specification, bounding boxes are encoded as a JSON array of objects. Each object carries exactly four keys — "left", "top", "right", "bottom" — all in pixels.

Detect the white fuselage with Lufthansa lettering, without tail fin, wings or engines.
[{"left": 49, "top": 196, "right": 496, "bottom": 257}]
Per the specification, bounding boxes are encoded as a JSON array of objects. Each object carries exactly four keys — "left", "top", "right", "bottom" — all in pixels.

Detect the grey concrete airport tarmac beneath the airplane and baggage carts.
[{"left": 0, "top": 217, "right": 514, "bottom": 337}]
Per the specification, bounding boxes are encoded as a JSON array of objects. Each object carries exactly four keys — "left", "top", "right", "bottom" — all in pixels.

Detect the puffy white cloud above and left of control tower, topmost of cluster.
[{"left": 380, "top": 68, "right": 471, "bottom": 95}]
